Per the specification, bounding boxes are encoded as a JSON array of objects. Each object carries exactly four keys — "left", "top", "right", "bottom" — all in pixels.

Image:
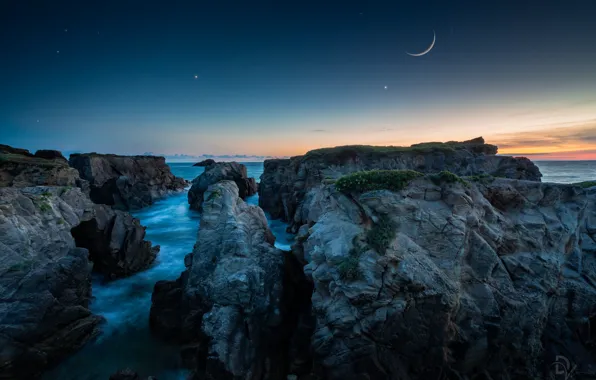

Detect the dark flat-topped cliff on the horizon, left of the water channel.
[{"left": 69, "top": 153, "right": 186, "bottom": 210}]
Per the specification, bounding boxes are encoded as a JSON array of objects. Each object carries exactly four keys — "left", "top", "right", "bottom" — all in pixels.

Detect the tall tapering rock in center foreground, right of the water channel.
[{"left": 150, "top": 181, "right": 312, "bottom": 379}]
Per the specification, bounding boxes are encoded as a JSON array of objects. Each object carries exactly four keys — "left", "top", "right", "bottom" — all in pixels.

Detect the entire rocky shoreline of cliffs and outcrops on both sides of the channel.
[{"left": 0, "top": 138, "right": 596, "bottom": 380}]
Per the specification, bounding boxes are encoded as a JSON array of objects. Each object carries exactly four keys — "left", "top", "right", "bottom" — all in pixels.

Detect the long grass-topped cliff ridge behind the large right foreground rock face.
[{"left": 259, "top": 138, "right": 542, "bottom": 232}]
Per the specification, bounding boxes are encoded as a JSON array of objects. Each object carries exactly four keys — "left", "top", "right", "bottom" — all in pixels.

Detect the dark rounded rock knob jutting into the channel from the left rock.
[{"left": 72, "top": 205, "right": 159, "bottom": 279}]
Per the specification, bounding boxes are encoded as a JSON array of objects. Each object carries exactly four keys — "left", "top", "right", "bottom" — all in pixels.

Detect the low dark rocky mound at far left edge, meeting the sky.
[{"left": 0, "top": 145, "right": 85, "bottom": 188}]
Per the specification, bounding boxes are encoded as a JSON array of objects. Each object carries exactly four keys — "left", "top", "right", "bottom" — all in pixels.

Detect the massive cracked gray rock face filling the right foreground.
[{"left": 294, "top": 177, "right": 596, "bottom": 379}]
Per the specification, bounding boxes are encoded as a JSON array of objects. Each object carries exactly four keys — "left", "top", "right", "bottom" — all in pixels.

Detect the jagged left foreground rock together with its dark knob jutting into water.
[{"left": 0, "top": 186, "right": 158, "bottom": 379}]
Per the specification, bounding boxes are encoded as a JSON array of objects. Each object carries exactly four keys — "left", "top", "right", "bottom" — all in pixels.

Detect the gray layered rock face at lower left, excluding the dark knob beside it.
[{"left": 0, "top": 187, "right": 101, "bottom": 379}]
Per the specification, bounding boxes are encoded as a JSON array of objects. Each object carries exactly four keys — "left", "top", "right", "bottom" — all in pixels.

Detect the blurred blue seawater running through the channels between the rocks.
[{"left": 44, "top": 162, "right": 292, "bottom": 380}]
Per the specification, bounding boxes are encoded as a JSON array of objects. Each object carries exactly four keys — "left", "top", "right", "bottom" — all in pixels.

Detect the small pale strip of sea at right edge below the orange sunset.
[{"left": 535, "top": 161, "right": 596, "bottom": 183}]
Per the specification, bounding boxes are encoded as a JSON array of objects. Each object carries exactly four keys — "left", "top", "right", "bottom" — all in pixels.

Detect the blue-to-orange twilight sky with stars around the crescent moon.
[{"left": 0, "top": 0, "right": 596, "bottom": 159}]
